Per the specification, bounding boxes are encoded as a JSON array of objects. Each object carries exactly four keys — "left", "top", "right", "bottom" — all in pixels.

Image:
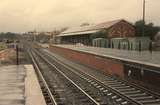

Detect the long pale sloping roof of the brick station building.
[{"left": 58, "top": 19, "right": 124, "bottom": 36}]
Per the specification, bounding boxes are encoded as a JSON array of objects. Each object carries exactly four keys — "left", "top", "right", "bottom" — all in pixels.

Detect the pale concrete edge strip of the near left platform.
[{"left": 24, "top": 65, "right": 46, "bottom": 105}]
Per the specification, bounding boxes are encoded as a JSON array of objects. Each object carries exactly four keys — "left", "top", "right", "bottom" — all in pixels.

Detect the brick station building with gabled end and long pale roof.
[{"left": 58, "top": 19, "right": 135, "bottom": 45}]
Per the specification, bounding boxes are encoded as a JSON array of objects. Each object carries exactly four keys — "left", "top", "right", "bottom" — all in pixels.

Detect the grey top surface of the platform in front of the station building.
[{"left": 52, "top": 45, "right": 160, "bottom": 67}]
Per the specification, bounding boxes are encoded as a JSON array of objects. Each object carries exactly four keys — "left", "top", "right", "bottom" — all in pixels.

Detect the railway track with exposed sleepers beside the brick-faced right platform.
[{"left": 38, "top": 47, "right": 160, "bottom": 105}]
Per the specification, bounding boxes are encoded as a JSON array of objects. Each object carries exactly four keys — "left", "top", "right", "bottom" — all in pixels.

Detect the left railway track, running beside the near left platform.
[{"left": 28, "top": 49, "right": 100, "bottom": 105}]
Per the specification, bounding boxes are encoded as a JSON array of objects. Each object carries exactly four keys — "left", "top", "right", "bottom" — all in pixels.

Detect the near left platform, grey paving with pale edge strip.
[{"left": 0, "top": 65, "right": 46, "bottom": 105}]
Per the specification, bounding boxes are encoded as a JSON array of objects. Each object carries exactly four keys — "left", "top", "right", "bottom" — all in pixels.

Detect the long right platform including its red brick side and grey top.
[{"left": 49, "top": 45, "right": 160, "bottom": 87}]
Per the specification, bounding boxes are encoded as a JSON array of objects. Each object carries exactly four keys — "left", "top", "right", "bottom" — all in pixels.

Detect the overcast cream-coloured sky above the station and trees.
[{"left": 0, "top": 0, "right": 160, "bottom": 32}]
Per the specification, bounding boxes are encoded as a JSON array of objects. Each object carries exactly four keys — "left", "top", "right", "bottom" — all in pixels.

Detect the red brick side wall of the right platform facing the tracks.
[{"left": 49, "top": 46, "right": 124, "bottom": 78}]
